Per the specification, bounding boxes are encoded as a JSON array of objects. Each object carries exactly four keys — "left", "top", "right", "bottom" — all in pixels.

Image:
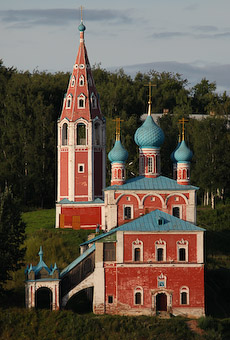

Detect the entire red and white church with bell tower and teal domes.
[{"left": 25, "top": 16, "right": 205, "bottom": 317}]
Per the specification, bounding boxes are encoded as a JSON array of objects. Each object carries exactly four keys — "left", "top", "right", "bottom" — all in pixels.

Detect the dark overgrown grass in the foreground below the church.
[{"left": 0, "top": 309, "right": 208, "bottom": 340}]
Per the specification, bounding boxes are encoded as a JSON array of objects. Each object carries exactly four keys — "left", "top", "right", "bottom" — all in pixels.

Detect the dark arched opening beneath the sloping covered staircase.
[{"left": 65, "top": 287, "right": 93, "bottom": 314}]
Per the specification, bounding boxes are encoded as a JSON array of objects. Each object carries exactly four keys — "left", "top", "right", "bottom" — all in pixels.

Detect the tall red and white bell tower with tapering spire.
[{"left": 56, "top": 12, "right": 106, "bottom": 226}]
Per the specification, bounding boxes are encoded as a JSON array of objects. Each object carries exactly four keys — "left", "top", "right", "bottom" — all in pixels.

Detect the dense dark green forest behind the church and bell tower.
[{"left": 0, "top": 60, "right": 230, "bottom": 211}]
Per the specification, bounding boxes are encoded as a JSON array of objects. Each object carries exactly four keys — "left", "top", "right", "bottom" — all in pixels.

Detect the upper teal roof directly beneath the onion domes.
[{"left": 104, "top": 176, "right": 199, "bottom": 191}]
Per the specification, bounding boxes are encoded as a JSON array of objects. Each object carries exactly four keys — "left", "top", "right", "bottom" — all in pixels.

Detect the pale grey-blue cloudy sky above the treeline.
[{"left": 0, "top": 0, "right": 230, "bottom": 94}]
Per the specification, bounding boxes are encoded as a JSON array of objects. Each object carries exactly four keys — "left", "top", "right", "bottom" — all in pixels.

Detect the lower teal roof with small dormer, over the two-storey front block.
[{"left": 81, "top": 210, "right": 205, "bottom": 245}]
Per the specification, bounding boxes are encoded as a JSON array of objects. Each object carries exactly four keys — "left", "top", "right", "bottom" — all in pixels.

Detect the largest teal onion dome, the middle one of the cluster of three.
[{"left": 134, "top": 115, "right": 165, "bottom": 148}]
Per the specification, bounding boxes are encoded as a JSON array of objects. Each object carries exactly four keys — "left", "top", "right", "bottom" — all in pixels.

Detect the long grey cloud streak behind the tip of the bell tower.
[{"left": 0, "top": 8, "right": 132, "bottom": 28}]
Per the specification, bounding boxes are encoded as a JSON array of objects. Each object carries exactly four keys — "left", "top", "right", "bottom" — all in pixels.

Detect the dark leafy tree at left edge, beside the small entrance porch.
[{"left": 0, "top": 188, "right": 26, "bottom": 290}]
